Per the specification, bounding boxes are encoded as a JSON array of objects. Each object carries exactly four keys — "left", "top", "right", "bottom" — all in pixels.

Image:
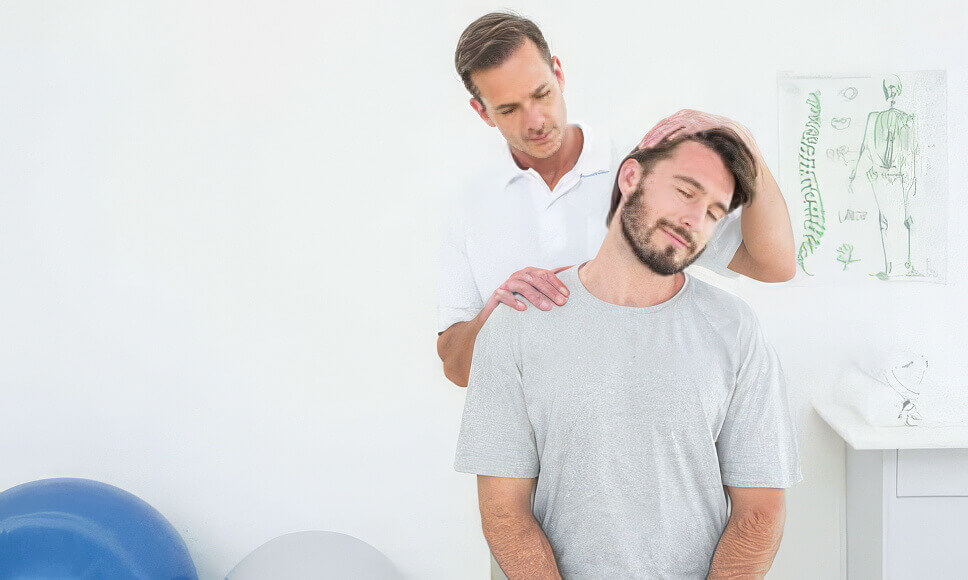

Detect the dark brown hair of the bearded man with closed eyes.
[{"left": 605, "top": 127, "right": 756, "bottom": 225}]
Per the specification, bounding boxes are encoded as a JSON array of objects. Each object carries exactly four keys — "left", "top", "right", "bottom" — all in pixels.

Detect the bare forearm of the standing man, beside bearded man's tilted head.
[{"left": 740, "top": 159, "right": 796, "bottom": 282}]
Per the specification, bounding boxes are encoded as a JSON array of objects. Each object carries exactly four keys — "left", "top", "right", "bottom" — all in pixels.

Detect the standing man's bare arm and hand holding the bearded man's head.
[{"left": 639, "top": 109, "right": 797, "bottom": 282}]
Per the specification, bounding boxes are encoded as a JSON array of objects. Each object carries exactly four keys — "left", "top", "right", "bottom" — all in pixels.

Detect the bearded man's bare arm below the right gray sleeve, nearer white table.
[{"left": 707, "top": 486, "right": 786, "bottom": 580}]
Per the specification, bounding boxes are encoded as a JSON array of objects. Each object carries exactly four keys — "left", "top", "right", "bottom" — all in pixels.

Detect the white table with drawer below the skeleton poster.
[{"left": 814, "top": 400, "right": 968, "bottom": 580}]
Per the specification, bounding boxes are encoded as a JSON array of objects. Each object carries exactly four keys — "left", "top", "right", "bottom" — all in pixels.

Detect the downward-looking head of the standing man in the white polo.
[{"left": 454, "top": 12, "right": 567, "bottom": 159}]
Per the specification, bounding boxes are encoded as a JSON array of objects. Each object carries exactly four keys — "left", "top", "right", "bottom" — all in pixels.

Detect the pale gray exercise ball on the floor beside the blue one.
[{"left": 225, "top": 531, "right": 403, "bottom": 580}]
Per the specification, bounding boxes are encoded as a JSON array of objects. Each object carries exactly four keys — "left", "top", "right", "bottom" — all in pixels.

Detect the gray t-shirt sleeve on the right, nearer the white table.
[{"left": 716, "top": 312, "right": 803, "bottom": 488}]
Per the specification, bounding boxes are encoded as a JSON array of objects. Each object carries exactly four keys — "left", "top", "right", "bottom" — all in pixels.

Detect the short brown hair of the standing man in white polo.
[{"left": 454, "top": 12, "right": 551, "bottom": 105}]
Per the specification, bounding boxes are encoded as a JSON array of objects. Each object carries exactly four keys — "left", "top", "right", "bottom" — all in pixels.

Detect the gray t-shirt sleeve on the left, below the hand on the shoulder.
[{"left": 454, "top": 304, "right": 539, "bottom": 477}]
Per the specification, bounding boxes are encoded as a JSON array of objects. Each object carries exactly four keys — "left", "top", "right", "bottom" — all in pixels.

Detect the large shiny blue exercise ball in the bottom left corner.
[{"left": 0, "top": 478, "right": 198, "bottom": 580}]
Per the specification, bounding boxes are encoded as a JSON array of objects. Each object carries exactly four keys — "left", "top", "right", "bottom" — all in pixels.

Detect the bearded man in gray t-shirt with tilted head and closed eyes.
[{"left": 455, "top": 129, "right": 801, "bottom": 580}]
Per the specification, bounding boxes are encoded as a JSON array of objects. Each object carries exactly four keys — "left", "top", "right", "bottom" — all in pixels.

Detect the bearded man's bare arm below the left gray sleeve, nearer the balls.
[{"left": 477, "top": 475, "right": 561, "bottom": 580}]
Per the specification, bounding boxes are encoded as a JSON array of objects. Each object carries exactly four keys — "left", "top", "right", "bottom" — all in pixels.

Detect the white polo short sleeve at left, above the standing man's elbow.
[{"left": 437, "top": 201, "right": 484, "bottom": 332}]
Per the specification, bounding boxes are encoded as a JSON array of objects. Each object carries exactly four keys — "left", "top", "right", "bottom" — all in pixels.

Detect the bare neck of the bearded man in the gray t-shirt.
[{"left": 578, "top": 225, "right": 686, "bottom": 307}]
